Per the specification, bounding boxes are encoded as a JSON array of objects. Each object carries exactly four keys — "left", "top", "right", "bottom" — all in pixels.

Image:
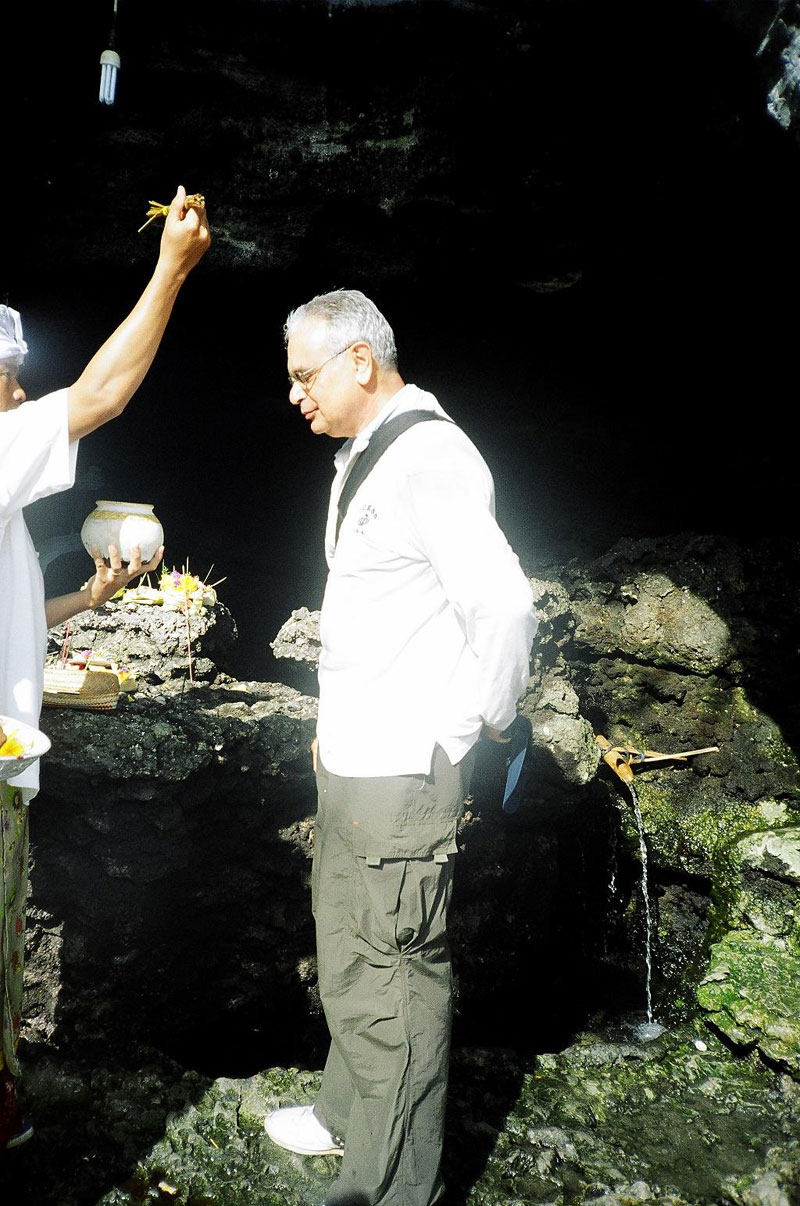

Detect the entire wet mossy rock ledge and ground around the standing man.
[{"left": 0, "top": 535, "right": 800, "bottom": 1206}]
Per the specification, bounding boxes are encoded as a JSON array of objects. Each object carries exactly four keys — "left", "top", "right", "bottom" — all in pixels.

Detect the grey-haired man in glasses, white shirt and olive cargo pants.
[{"left": 265, "top": 289, "right": 536, "bottom": 1206}]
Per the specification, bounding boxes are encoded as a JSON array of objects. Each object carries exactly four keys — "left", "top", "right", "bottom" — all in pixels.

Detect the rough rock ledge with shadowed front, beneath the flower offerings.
[{"left": 27, "top": 604, "right": 316, "bottom": 1046}]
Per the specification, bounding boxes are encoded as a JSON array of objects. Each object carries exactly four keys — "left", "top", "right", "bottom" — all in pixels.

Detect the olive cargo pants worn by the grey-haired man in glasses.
[{"left": 313, "top": 747, "right": 469, "bottom": 1206}]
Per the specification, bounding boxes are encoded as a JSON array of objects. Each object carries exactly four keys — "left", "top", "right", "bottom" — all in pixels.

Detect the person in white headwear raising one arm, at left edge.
[{"left": 0, "top": 187, "right": 210, "bottom": 1153}]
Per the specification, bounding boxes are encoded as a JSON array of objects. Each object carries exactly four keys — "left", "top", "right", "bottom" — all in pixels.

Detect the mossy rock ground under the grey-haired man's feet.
[{"left": 0, "top": 1029, "right": 800, "bottom": 1206}]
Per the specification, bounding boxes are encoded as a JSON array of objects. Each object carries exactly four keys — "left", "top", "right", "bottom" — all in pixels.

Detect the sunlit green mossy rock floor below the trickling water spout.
[{"left": 460, "top": 1030, "right": 800, "bottom": 1206}]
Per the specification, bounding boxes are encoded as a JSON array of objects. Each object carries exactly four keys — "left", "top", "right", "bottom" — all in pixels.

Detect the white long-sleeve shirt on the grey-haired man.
[{"left": 317, "top": 385, "right": 537, "bottom": 778}]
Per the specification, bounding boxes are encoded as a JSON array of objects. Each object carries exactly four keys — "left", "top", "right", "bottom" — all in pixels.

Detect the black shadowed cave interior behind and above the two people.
[{"left": 0, "top": 0, "right": 798, "bottom": 678}]
